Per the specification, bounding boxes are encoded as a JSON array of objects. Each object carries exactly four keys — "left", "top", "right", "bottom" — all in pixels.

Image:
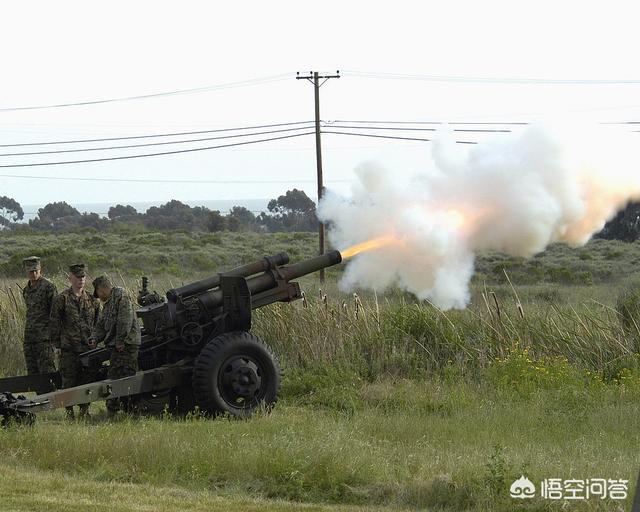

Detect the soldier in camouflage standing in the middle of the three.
[{"left": 51, "top": 263, "right": 100, "bottom": 419}]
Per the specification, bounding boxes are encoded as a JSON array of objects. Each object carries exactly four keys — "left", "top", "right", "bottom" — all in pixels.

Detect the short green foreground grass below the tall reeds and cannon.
[{"left": 0, "top": 380, "right": 640, "bottom": 511}]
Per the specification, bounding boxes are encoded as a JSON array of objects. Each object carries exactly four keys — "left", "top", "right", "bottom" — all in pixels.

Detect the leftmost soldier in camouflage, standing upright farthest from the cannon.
[{"left": 22, "top": 256, "right": 58, "bottom": 375}]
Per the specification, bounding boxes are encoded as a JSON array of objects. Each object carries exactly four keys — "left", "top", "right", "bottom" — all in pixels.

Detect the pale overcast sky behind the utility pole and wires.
[{"left": 0, "top": 0, "right": 640, "bottom": 211}]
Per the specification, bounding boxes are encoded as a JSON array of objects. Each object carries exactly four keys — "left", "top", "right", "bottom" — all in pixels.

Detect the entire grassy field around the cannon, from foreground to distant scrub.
[{"left": 0, "top": 233, "right": 640, "bottom": 511}]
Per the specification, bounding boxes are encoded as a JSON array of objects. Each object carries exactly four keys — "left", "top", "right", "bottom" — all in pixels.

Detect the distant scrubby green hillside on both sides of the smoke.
[{"left": 0, "top": 230, "right": 640, "bottom": 285}]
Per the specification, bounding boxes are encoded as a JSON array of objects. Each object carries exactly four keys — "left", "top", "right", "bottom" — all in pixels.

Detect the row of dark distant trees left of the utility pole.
[{"left": 0, "top": 188, "right": 318, "bottom": 232}]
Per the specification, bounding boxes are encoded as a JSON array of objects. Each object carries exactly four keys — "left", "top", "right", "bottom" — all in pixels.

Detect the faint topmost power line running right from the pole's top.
[{"left": 343, "top": 71, "right": 640, "bottom": 85}]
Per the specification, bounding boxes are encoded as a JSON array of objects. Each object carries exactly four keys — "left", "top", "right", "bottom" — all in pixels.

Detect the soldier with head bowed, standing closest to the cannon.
[{"left": 93, "top": 276, "right": 140, "bottom": 416}]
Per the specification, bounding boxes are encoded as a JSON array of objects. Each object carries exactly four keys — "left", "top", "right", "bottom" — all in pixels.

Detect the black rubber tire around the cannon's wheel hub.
[{"left": 192, "top": 331, "right": 282, "bottom": 418}]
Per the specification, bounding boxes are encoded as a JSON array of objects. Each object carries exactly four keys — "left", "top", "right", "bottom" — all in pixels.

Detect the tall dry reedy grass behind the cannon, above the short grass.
[{"left": 0, "top": 273, "right": 639, "bottom": 380}]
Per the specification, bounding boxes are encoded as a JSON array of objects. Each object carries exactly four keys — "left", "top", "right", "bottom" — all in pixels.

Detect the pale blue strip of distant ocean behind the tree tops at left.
[{"left": 22, "top": 199, "right": 269, "bottom": 222}]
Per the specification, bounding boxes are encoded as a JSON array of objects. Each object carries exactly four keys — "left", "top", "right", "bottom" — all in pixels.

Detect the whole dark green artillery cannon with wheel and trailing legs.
[{"left": 0, "top": 251, "right": 342, "bottom": 423}]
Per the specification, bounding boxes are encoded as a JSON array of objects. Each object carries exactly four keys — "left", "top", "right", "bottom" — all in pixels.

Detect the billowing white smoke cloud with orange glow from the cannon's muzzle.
[{"left": 318, "top": 125, "right": 640, "bottom": 309}]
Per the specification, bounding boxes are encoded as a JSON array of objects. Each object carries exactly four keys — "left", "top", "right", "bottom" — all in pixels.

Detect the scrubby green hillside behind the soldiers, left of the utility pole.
[{"left": 0, "top": 231, "right": 317, "bottom": 280}]
